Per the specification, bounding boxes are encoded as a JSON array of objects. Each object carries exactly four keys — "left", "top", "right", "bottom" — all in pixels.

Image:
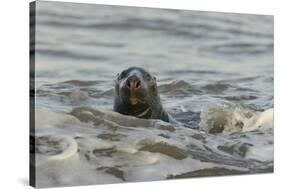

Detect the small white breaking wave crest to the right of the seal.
[{"left": 199, "top": 104, "right": 273, "bottom": 133}]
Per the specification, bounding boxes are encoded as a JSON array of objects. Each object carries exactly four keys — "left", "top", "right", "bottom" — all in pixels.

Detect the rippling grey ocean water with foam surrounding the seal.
[{"left": 31, "top": 1, "right": 274, "bottom": 187}]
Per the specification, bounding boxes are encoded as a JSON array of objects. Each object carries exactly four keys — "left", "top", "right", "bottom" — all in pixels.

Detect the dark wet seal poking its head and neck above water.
[{"left": 113, "top": 67, "right": 169, "bottom": 122}]
